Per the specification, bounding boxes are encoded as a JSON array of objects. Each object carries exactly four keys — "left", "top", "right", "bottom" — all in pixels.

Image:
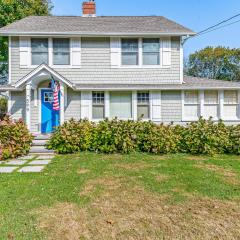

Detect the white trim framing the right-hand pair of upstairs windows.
[{"left": 119, "top": 37, "right": 171, "bottom": 69}]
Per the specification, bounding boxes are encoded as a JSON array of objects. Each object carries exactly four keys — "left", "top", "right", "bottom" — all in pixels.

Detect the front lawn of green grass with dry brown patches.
[{"left": 0, "top": 153, "right": 240, "bottom": 240}]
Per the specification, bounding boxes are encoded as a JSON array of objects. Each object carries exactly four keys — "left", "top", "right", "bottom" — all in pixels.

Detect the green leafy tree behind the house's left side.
[{"left": 0, "top": 0, "right": 53, "bottom": 77}]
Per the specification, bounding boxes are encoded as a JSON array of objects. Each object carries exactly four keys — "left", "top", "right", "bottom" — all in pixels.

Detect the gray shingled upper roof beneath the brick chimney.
[{"left": 0, "top": 16, "right": 195, "bottom": 36}]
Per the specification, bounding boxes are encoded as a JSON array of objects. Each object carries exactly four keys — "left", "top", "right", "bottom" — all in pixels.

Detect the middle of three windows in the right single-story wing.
[{"left": 203, "top": 91, "right": 219, "bottom": 119}]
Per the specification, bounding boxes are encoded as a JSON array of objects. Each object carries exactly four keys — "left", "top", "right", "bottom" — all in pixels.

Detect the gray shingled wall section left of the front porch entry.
[{"left": 10, "top": 91, "right": 26, "bottom": 121}]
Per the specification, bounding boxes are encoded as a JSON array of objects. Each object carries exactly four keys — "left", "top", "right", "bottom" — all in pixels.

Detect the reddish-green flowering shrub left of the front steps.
[{"left": 0, "top": 116, "right": 33, "bottom": 160}]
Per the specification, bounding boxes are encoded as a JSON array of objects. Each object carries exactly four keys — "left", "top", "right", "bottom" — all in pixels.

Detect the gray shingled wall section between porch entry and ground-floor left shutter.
[{"left": 64, "top": 88, "right": 81, "bottom": 121}]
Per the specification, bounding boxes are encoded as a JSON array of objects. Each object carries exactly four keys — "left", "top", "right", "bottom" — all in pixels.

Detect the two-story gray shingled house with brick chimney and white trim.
[{"left": 0, "top": 1, "right": 240, "bottom": 133}]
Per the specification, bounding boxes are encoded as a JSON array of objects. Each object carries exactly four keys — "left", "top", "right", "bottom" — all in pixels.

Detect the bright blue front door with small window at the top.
[{"left": 41, "top": 89, "right": 60, "bottom": 133}]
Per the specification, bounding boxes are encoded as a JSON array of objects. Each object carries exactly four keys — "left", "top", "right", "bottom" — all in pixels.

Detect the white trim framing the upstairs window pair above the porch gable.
[{"left": 24, "top": 37, "right": 80, "bottom": 69}]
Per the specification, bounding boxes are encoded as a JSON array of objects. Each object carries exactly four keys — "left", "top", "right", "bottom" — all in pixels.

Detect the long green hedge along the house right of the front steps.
[{"left": 48, "top": 119, "right": 240, "bottom": 154}]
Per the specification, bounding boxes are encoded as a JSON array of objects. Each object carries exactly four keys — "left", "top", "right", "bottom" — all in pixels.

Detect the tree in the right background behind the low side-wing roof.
[{"left": 185, "top": 47, "right": 240, "bottom": 81}]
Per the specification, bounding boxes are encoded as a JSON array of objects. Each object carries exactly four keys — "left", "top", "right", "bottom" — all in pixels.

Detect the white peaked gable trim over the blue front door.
[{"left": 14, "top": 64, "right": 74, "bottom": 88}]
